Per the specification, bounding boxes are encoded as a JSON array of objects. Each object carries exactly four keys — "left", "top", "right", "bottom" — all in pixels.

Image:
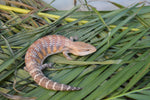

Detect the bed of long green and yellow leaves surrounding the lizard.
[{"left": 0, "top": 0, "right": 150, "bottom": 100}]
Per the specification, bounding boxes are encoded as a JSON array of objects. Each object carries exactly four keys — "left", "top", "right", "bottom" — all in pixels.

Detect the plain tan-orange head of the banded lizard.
[{"left": 69, "top": 42, "right": 96, "bottom": 56}]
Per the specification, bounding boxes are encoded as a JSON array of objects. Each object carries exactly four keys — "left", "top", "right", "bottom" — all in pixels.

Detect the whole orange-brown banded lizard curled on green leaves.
[{"left": 24, "top": 35, "right": 96, "bottom": 91}]
